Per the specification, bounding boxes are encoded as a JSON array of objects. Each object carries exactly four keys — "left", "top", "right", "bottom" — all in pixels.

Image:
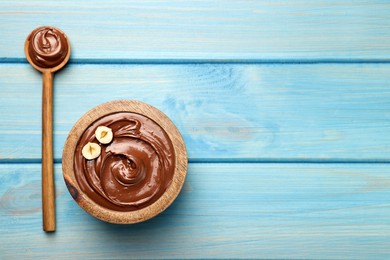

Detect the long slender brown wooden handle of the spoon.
[{"left": 42, "top": 71, "right": 56, "bottom": 232}]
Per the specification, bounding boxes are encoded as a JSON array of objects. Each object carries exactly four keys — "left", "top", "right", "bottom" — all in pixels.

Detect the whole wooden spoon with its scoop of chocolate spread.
[{"left": 24, "top": 26, "right": 70, "bottom": 232}]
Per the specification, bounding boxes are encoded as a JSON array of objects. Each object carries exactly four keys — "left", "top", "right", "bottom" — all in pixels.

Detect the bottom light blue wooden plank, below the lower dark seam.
[{"left": 0, "top": 164, "right": 390, "bottom": 259}]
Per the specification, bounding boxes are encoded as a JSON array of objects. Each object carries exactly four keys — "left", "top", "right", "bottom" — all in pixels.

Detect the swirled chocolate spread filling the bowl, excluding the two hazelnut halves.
[{"left": 73, "top": 112, "right": 175, "bottom": 211}]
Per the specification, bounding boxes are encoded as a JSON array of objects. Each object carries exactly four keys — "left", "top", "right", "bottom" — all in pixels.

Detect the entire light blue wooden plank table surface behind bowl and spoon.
[{"left": 0, "top": 0, "right": 390, "bottom": 259}]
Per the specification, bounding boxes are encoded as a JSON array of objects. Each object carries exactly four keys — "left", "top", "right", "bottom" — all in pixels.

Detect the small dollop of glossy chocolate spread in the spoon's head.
[{"left": 28, "top": 26, "right": 69, "bottom": 68}]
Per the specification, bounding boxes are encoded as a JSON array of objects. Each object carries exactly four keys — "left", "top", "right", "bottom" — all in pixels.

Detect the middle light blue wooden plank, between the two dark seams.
[{"left": 0, "top": 64, "right": 390, "bottom": 161}]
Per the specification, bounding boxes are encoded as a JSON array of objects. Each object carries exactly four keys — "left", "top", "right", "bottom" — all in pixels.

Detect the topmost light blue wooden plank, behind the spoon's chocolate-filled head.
[{"left": 0, "top": 0, "right": 390, "bottom": 60}]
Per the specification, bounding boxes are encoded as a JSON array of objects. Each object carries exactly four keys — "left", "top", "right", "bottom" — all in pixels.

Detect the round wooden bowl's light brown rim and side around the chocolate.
[{"left": 62, "top": 100, "right": 188, "bottom": 224}]
